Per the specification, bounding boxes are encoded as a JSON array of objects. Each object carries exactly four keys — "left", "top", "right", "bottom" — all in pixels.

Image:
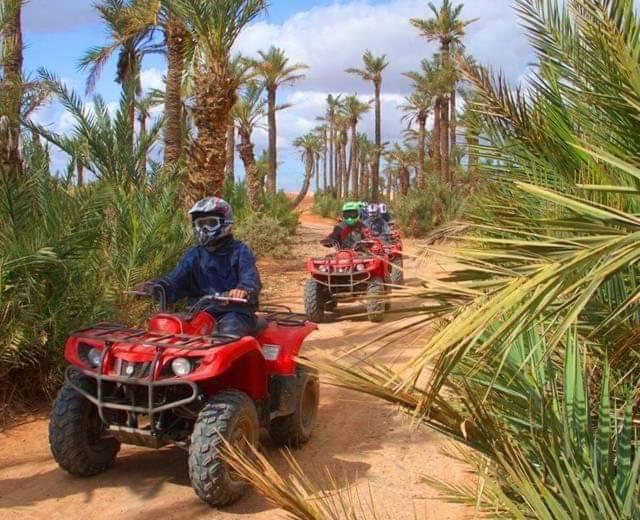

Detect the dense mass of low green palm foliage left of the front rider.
[{"left": 0, "top": 164, "right": 190, "bottom": 390}]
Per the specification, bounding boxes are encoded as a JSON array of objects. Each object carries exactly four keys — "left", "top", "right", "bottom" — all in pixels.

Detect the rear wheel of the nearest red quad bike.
[{"left": 269, "top": 366, "right": 320, "bottom": 447}]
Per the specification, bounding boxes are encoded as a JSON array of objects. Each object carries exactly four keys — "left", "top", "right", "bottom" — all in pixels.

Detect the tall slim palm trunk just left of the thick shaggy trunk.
[{"left": 164, "top": 14, "right": 185, "bottom": 167}]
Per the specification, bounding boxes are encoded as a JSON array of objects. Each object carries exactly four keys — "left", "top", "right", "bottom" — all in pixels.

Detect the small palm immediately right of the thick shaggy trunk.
[{"left": 231, "top": 82, "right": 267, "bottom": 211}]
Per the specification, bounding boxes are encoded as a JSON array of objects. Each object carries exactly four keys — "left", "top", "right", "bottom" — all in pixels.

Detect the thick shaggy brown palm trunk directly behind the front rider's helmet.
[{"left": 185, "top": 68, "right": 236, "bottom": 203}]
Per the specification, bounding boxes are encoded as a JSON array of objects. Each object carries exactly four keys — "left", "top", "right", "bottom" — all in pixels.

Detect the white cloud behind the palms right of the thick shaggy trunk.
[{"left": 236, "top": 0, "right": 532, "bottom": 189}]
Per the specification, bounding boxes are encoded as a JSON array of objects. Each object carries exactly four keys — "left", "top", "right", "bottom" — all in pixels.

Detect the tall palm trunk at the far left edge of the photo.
[{"left": 0, "top": 2, "right": 23, "bottom": 178}]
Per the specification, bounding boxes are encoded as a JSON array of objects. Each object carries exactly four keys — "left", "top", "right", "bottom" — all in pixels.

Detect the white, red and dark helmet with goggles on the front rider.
[{"left": 189, "top": 197, "right": 233, "bottom": 247}]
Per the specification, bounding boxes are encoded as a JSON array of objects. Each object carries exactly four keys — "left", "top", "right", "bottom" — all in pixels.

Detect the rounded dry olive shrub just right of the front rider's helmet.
[{"left": 234, "top": 213, "right": 289, "bottom": 258}]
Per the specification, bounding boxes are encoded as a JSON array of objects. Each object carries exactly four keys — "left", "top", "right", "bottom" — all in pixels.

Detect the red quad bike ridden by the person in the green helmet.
[{"left": 304, "top": 239, "right": 391, "bottom": 323}]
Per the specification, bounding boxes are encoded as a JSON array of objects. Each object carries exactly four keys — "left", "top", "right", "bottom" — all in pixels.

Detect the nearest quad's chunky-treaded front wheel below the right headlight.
[{"left": 189, "top": 390, "right": 260, "bottom": 506}]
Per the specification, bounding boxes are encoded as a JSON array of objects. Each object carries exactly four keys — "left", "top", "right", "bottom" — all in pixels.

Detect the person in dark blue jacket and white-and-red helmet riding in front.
[{"left": 137, "top": 197, "right": 261, "bottom": 337}]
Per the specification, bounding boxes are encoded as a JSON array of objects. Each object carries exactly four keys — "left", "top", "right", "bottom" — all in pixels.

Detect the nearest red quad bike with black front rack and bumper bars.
[{"left": 49, "top": 287, "right": 319, "bottom": 506}]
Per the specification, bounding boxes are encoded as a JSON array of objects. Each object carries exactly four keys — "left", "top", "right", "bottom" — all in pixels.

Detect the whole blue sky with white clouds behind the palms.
[{"left": 23, "top": 0, "right": 533, "bottom": 190}]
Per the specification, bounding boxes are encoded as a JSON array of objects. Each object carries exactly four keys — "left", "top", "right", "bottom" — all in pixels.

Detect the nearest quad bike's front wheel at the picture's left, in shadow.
[{"left": 49, "top": 377, "right": 120, "bottom": 477}]
